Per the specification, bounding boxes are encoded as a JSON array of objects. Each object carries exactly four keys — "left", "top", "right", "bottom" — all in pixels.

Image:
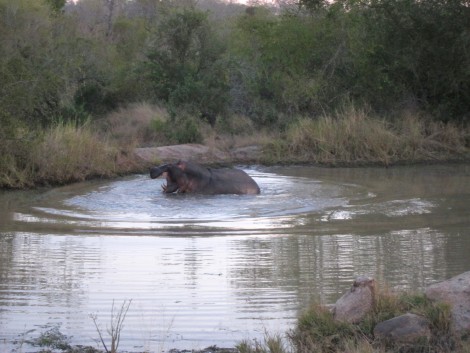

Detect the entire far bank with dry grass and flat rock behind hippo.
[{"left": 0, "top": 107, "right": 470, "bottom": 189}]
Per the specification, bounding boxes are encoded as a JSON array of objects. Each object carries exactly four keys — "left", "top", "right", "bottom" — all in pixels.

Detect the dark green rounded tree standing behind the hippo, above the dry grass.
[{"left": 146, "top": 7, "right": 228, "bottom": 125}]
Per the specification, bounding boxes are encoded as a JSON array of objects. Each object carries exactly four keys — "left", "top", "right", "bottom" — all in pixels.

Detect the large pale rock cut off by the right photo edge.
[{"left": 425, "top": 271, "right": 470, "bottom": 335}]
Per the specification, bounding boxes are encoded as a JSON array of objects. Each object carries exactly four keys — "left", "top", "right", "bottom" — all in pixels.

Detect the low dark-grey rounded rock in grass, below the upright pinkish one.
[{"left": 374, "top": 313, "right": 431, "bottom": 345}]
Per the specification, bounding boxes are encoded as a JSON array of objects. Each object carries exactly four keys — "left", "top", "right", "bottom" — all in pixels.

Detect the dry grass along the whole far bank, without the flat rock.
[{"left": 0, "top": 103, "right": 470, "bottom": 188}]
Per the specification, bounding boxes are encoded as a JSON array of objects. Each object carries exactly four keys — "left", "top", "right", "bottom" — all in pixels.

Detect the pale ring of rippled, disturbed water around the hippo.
[{"left": 15, "top": 170, "right": 356, "bottom": 234}]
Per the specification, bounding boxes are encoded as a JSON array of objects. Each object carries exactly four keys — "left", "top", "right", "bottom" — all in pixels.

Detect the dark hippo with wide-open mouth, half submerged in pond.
[{"left": 150, "top": 161, "right": 260, "bottom": 195}]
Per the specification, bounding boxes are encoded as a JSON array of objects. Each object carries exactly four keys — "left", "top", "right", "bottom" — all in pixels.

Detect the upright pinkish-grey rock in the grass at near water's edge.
[{"left": 333, "top": 276, "right": 375, "bottom": 323}]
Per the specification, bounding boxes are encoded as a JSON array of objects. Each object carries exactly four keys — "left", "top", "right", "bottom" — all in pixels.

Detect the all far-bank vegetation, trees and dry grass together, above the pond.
[{"left": 0, "top": 0, "right": 470, "bottom": 188}]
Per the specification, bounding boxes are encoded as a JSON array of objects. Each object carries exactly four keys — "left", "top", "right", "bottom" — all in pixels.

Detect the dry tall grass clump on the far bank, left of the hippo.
[{"left": 0, "top": 122, "right": 139, "bottom": 188}]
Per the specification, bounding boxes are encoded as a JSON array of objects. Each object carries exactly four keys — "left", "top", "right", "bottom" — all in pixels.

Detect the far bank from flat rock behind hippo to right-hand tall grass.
[{"left": 135, "top": 106, "right": 470, "bottom": 167}]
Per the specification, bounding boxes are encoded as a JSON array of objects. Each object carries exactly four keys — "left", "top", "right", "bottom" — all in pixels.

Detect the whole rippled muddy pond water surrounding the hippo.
[{"left": 0, "top": 165, "right": 470, "bottom": 352}]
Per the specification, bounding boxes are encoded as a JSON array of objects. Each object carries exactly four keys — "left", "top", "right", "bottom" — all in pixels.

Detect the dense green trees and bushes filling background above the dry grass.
[{"left": 0, "top": 0, "right": 470, "bottom": 187}]
